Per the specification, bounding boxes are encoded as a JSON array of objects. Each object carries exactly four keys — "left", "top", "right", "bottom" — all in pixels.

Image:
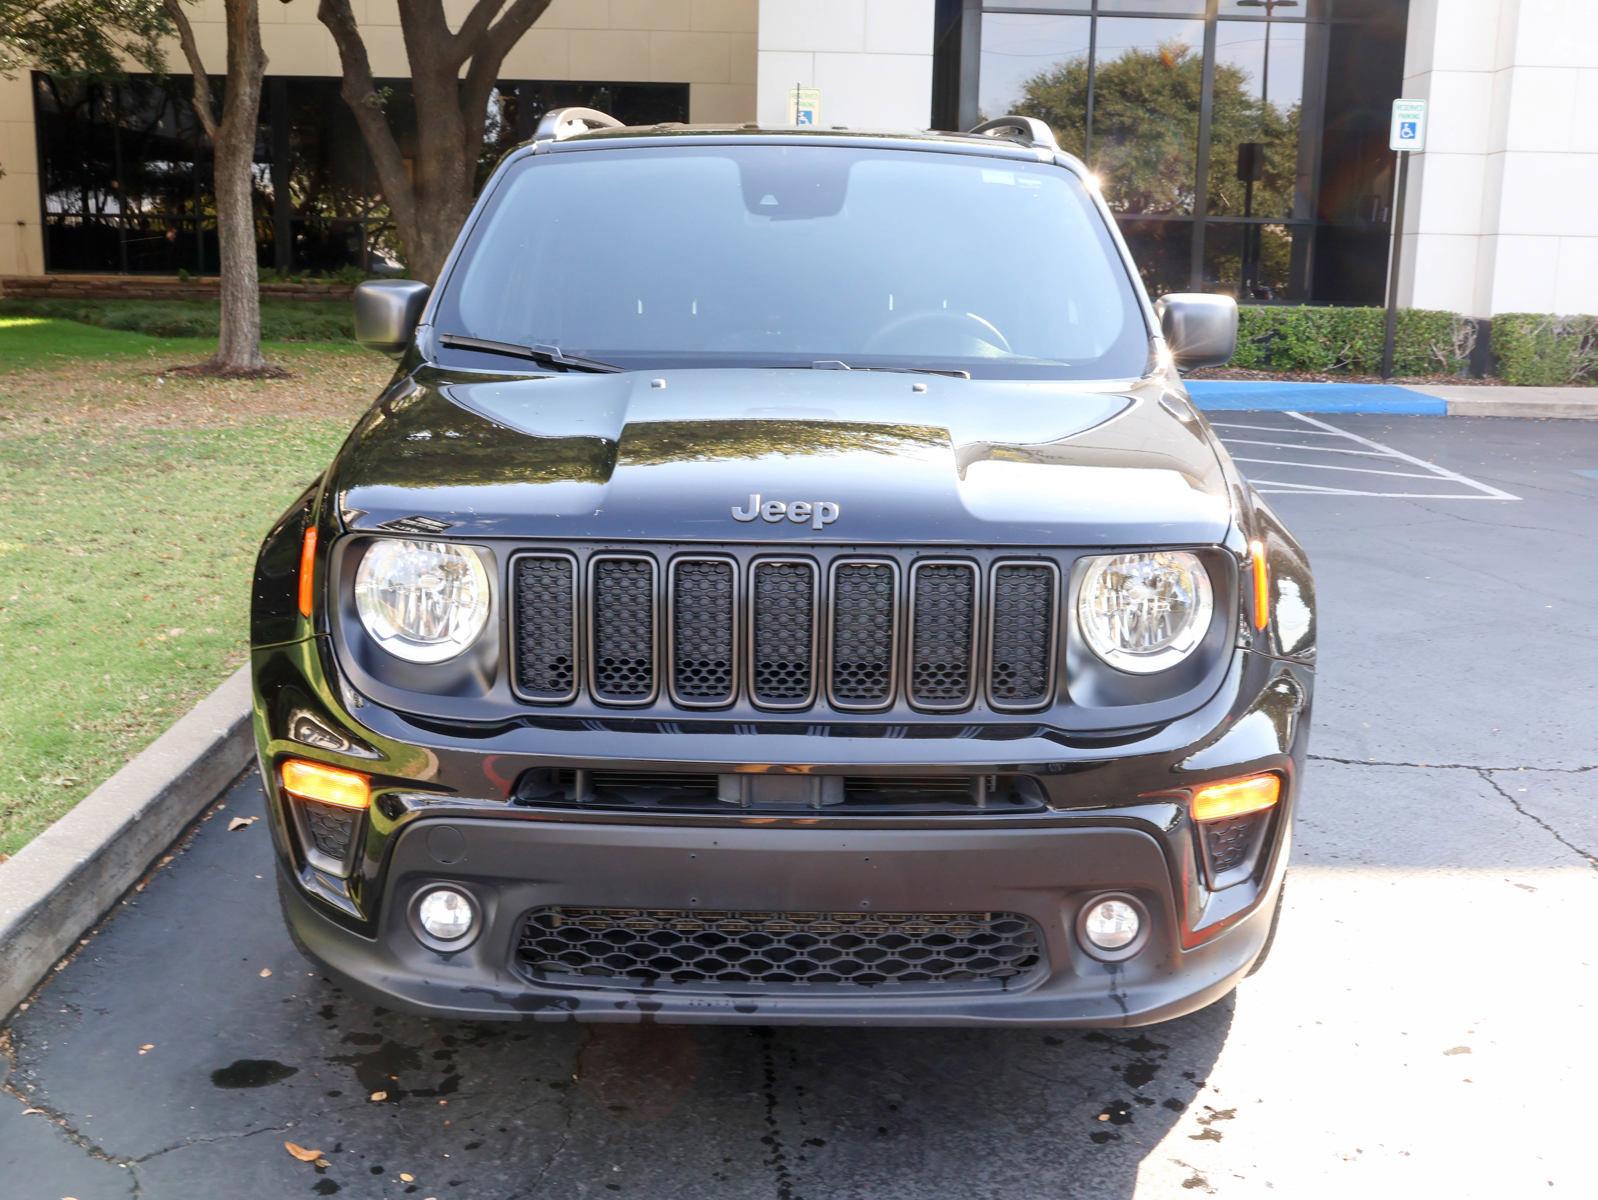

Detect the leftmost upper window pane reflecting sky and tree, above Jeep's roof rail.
[{"left": 978, "top": 13, "right": 1093, "bottom": 158}]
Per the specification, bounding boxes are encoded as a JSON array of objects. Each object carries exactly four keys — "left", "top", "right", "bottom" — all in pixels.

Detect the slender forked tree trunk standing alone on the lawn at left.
[{"left": 163, "top": 0, "right": 280, "bottom": 375}]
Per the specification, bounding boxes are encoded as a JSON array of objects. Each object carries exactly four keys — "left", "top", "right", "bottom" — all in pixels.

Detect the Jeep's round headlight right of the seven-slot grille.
[{"left": 1077, "top": 550, "right": 1214, "bottom": 674}]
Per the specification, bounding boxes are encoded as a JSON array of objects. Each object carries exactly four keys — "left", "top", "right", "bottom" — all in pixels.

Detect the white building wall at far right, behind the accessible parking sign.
[{"left": 1400, "top": 0, "right": 1598, "bottom": 316}]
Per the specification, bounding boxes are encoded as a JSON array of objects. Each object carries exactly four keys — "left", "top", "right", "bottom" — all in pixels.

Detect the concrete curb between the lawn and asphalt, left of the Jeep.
[{"left": 0, "top": 666, "right": 251, "bottom": 1021}]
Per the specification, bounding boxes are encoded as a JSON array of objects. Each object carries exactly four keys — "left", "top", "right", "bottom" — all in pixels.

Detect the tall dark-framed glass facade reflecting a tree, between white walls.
[{"left": 933, "top": 0, "right": 1408, "bottom": 304}]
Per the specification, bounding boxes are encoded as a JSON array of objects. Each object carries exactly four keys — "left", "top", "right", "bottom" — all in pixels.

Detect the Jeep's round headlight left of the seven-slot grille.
[{"left": 355, "top": 538, "right": 489, "bottom": 663}]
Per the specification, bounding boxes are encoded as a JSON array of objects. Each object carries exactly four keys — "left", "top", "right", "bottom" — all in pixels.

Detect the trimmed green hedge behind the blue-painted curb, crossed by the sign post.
[{"left": 1232, "top": 305, "right": 1477, "bottom": 375}]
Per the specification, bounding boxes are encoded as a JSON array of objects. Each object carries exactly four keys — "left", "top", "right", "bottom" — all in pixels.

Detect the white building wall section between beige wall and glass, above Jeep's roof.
[{"left": 756, "top": 0, "right": 935, "bottom": 129}]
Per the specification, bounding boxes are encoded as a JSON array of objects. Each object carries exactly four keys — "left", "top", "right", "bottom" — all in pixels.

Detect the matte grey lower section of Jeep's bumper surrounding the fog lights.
[{"left": 280, "top": 821, "right": 1285, "bottom": 1026}]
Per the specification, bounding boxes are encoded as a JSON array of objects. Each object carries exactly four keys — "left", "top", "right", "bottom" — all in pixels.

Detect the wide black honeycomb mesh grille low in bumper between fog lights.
[{"left": 516, "top": 908, "right": 1045, "bottom": 991}]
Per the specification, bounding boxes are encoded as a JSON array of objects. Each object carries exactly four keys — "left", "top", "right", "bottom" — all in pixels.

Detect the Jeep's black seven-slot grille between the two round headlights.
[{"left": 510, "top": 550, "right": 1061, "bottom": 713}]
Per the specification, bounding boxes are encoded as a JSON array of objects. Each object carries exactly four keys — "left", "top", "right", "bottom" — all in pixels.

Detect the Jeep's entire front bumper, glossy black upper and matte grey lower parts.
[{"left": 254, "top": 642, "right": 1314, "bottom": 1026}]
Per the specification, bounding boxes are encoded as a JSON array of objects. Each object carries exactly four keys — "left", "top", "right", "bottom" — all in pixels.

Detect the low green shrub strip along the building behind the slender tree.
[{"left": 0, "top": 296, "right": 355, "bottom": 342}]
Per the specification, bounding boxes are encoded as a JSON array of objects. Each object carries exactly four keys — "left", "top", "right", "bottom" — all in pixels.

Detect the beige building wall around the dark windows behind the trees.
[{"left": 0, "top": 0, "right": 757, "bottom": 275}]
